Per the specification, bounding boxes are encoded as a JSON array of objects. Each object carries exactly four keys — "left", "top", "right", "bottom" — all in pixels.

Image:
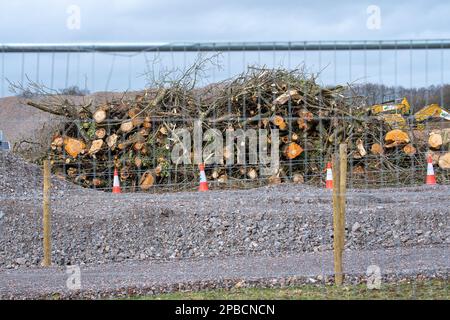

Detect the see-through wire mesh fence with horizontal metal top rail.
[{"left": 0, "top": 40, "right": 450, "bottom": 297}]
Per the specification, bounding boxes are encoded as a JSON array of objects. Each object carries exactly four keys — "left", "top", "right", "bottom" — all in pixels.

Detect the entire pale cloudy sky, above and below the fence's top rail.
[{"left": 0, "top": 0, "right": 450, "bottom": 93}]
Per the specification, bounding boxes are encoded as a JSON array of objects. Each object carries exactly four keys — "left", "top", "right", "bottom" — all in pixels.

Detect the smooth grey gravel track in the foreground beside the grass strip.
[{"left": 0, "top": 247, "right": 450, "bottom": 299}]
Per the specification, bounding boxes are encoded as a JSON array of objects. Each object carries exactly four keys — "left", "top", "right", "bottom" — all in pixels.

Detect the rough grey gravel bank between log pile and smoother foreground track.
[{"left": 0, "top": 153, "right": 450, "bottom": 298}]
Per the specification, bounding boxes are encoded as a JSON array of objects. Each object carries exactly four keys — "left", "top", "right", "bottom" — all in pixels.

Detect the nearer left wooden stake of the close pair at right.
[{"left": 333, "top": 155, "right": 342, "bottom": 286}]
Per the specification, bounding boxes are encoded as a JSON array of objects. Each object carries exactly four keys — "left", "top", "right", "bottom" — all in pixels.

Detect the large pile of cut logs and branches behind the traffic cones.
[{"left": 28, "top": 67, "right": 450, "bottom": 191}]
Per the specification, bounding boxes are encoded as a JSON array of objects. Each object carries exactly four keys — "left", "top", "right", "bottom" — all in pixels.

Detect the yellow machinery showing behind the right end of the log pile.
[{"left": 370, "top": 98, "right": 450, "bottom": 129}]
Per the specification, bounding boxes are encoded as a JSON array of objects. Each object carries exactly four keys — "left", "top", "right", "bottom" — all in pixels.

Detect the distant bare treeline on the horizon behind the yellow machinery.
[{"left": 353, "top": 83, "right": 450, "bottom": 112}]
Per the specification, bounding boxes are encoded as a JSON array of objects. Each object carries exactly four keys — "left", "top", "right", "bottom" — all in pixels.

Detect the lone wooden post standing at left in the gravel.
[{"left": 42, "top": 160, "right": 52, "bottom": 267}]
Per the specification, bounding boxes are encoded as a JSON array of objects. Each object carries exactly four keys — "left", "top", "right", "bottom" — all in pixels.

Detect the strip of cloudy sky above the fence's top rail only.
[{"left": 0, "top": 0, "right": 450, "bottom": 42}]
